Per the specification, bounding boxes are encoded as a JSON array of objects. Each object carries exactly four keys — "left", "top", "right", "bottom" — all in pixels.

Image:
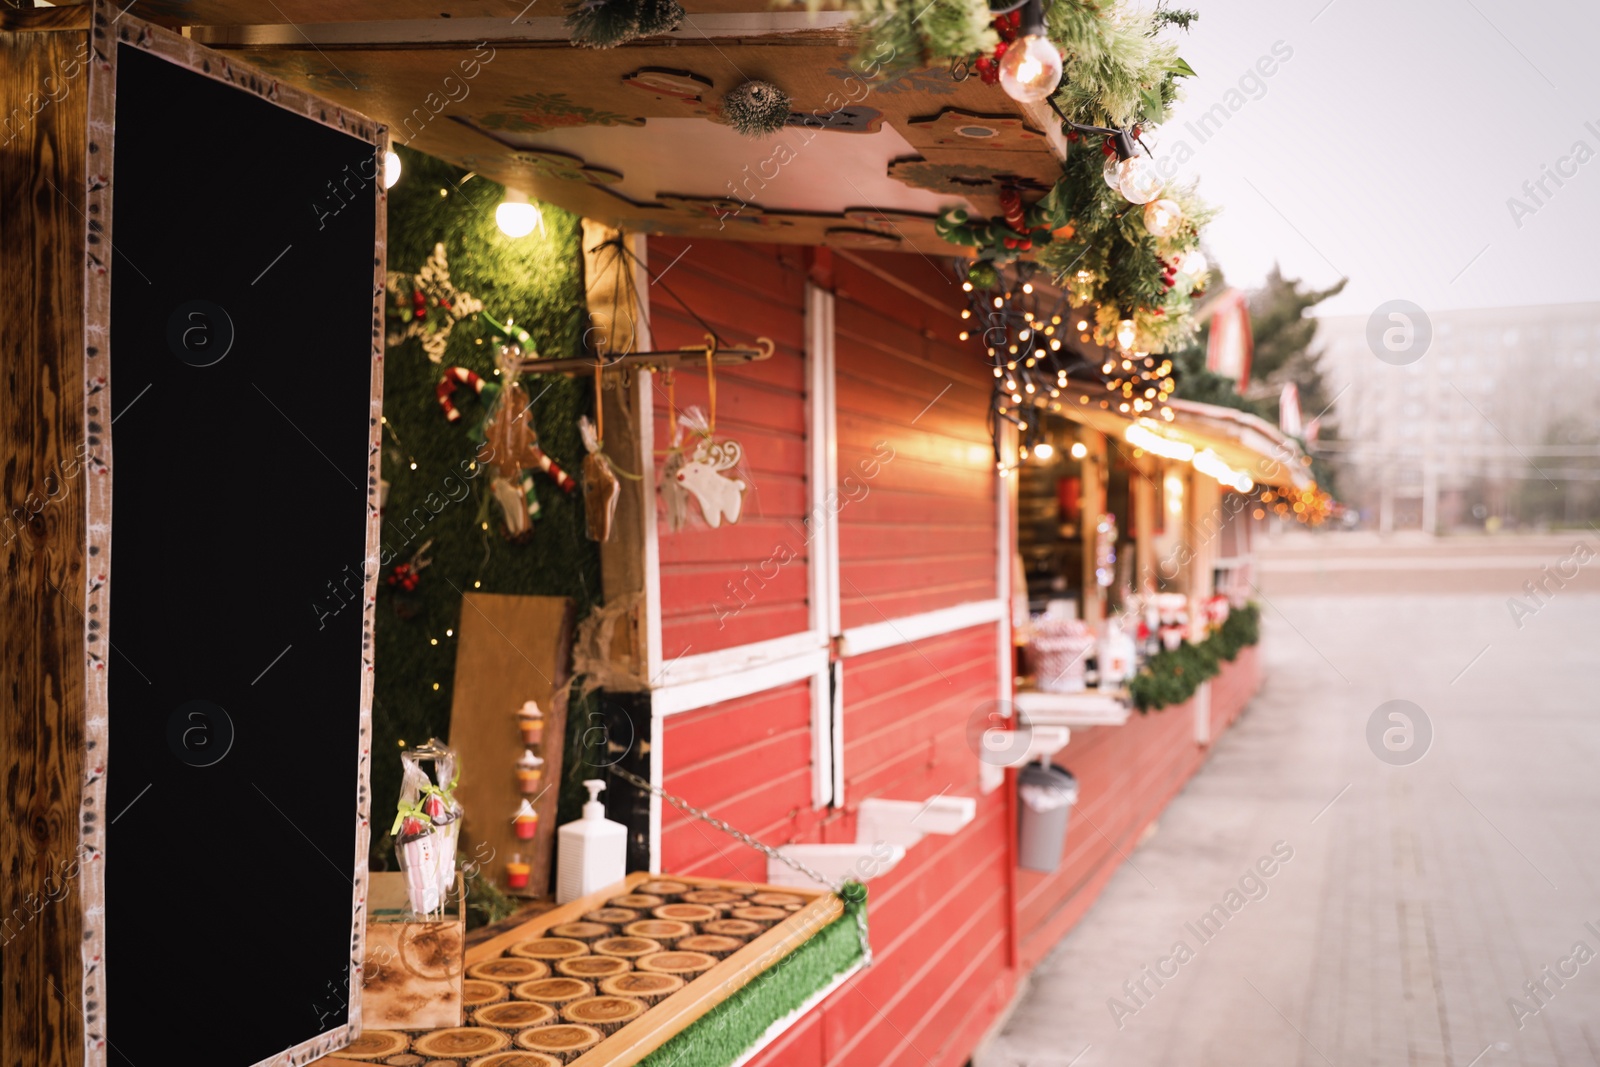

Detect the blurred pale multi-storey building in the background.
[{"left": 1307, "top": 302, "right": 1600, "bottom": 533}]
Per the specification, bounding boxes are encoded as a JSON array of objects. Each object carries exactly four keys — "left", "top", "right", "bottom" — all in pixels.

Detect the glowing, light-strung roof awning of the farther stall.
[{"left": 1059, "top": 391, "right": 1312, "bottom": 490}]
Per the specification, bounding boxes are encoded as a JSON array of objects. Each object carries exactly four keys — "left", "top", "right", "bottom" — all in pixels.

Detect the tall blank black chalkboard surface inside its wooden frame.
[{"left": 108, "top": 43, "right": 379, "bottom": 1067}]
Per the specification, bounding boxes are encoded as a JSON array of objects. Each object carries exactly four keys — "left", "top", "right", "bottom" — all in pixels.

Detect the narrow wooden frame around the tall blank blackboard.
[{"left": 78, "top": 0, "right": 389, "bottom": 1067}]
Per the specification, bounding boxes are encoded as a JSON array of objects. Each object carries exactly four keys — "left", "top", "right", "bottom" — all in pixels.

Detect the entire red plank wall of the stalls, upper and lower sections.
[{"left": 650, "top": 238, "right": 1258, "bottom": 1067}]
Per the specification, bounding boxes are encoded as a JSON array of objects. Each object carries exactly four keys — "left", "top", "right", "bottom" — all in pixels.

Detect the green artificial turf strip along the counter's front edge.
[{"left": 638, "top": 904, "right": 866, "bottom": 1067}]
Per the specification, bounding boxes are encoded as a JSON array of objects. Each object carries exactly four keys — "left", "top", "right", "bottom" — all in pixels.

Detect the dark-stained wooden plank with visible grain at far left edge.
[{"left": 0, "top": 10, "right": 90, "bottom": 1067}]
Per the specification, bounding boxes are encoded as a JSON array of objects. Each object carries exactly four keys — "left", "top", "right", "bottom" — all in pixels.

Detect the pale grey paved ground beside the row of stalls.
[{"left": 976, "top": 533, "right": 1600, "bottom": 1067}]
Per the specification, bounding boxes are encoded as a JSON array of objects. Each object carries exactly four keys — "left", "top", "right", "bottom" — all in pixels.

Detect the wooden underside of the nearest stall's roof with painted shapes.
[{"left": 141, "top": 0, "right": 1066, "bottom": 254}]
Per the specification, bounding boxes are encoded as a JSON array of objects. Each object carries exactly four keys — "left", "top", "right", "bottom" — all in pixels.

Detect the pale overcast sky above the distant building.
[{"left": 1147, "top": 0, "right": 1600, "bottom": 315}]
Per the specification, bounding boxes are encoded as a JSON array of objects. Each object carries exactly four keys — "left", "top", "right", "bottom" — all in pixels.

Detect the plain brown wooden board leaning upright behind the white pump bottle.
[{"left": 450, "top": 593, "right": 573, "bottom": 897}]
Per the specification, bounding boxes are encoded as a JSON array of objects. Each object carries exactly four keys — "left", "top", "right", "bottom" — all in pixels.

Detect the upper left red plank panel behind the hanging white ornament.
[{"left": 650, "top": 237, "right": 810, "bottom": 662}]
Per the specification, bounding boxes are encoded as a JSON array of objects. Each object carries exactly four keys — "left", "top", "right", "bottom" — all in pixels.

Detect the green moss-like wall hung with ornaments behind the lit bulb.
[{"left": 371, "top": 149, "right": 600, "bottom": 867}]
